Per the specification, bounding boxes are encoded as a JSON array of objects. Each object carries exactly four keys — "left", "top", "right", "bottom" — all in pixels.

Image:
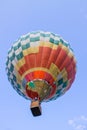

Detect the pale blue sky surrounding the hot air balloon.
[{"left": 0, "top": 0, "right": 87, "bottom": 130}]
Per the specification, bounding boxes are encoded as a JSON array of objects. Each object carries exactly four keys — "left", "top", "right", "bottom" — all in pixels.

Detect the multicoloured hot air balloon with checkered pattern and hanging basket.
[{"left": 6, "top": 31, "right": 76, "bottom": 116}]
